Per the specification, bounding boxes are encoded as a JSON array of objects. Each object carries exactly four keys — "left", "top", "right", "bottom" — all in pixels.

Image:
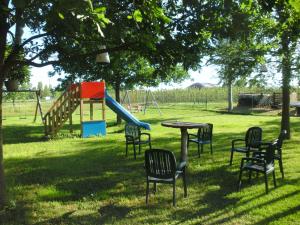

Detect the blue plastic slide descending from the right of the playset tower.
[{"left": 105, "top": 91, "right": 151, "bottom": 130}]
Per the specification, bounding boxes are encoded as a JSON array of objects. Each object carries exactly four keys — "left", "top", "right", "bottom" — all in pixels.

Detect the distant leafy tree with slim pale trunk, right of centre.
[{"left": 208, "top": 0, "right": 270, "bottom": 111}]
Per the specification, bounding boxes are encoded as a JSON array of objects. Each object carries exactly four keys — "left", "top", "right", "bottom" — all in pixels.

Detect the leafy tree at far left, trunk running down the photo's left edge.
[{"left": 0, "top": 0, "right": 177, "bottom": 208}]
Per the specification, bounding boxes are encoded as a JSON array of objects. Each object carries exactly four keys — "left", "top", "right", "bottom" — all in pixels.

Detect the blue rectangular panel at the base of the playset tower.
[{"left": 81, "top": 120, "right": 106, "bottom": 138}]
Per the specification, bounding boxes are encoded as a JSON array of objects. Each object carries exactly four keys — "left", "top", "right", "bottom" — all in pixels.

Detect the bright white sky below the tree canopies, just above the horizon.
[{"left": 30, "top": 66, "right": 219, "bottom": 89}]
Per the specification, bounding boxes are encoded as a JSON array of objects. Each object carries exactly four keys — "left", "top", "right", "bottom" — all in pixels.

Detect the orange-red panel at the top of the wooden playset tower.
[{"left": 80, "top": 81, "right": 105, "bottom": 98}]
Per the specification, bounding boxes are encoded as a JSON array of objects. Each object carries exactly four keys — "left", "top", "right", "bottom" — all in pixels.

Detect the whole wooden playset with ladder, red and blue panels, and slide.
[{"left": 43, "top": 81, "right": 150, "bottom": 137}]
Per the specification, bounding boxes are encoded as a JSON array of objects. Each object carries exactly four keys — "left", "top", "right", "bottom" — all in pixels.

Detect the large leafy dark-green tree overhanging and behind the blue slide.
[{"left": 49, "top": 1, "right": 216, "bottom": 123}]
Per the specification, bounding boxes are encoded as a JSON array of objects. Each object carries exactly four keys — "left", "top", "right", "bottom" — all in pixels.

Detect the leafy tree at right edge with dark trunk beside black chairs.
[{"left": 261, "top": 0, "right": 300, "bottom": 138}]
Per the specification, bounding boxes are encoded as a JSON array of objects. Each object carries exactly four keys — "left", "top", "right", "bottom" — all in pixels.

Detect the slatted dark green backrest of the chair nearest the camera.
[{"left": 145, "top": 149, "right": 176, "bottom": 179}]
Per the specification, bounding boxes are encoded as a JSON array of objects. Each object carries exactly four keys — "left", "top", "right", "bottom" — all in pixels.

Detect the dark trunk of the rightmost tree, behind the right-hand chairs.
[{"left": 281, "top": 35, "right": 292, "bottom": 139}]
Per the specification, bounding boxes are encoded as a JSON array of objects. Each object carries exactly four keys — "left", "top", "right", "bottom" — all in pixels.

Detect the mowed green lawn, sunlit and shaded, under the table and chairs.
[{"left": 0, "top": 104, "right": 300, "bottom": 225}]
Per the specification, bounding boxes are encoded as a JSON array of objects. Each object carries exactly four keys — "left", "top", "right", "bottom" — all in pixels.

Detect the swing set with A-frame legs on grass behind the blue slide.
[{"left": 121, "top": 90, "right": 162, "bottom": 115}]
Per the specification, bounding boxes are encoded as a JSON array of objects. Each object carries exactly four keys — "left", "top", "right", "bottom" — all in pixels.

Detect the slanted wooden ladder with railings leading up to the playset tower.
[{"left": 43, "top": 84, "right": 80, "bottom": 137}]
